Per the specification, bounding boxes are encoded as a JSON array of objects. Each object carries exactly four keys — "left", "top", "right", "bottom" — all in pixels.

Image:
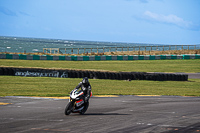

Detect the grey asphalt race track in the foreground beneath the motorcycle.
[{"left": 0, "top": 96, "right": 200, "bottom": 133}]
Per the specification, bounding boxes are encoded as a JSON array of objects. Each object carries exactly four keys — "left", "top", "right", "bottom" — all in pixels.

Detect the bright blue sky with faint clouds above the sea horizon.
[{"left": 0, "top": 0, "right": 200, "bottom": 44}]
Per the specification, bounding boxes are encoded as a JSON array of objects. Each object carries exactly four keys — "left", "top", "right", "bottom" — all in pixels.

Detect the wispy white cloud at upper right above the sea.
[{"left": 144, "top": 11, "right": 199, "bottom": 30}]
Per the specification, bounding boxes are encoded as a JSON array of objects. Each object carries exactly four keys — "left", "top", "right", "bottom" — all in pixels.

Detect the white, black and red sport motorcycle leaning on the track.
[{"left": 65, "top": 89, "right": 92, "bottom": 115}]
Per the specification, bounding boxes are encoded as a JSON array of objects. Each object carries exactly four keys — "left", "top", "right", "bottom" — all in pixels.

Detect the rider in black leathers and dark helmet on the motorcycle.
[{"left": 75, "top": 77, "right": 92, "bottom": 103}]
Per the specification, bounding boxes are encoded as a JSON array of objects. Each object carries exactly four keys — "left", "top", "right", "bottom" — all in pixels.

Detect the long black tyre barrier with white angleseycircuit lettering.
[{"left": 0, "top": 67, "right": 188, "bottom": 81}]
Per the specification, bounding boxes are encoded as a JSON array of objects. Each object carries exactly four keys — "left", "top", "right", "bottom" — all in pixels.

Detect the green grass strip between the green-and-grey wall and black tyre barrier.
[{"left": 0, "top": 59, "right": 200, "bottom": 73}]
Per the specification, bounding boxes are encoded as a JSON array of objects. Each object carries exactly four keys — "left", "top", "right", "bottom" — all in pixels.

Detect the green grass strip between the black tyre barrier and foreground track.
[{"left": 0, "top": 76, "right": 200, "bottom": 97}]
